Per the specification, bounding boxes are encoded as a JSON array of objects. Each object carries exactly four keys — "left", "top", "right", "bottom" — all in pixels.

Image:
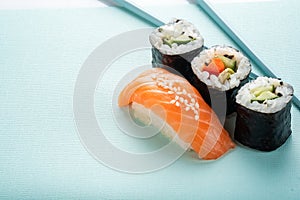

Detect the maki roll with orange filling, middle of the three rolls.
[{"left": 192, "top": 46, "right": 251, "bottom": 117}]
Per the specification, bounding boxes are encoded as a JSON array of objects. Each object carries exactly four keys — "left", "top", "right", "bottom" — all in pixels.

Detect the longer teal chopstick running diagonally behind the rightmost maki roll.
[{"left": 197, "top": 0, "right": 300, "bottom": 110}]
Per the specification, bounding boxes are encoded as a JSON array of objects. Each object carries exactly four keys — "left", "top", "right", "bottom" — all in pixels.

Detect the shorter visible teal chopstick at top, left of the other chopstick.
[{"left": 112, "top": 0, "right": 165, "bottom": 26}]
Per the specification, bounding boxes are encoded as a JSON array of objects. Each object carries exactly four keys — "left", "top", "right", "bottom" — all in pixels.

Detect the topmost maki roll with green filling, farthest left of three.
[{"left": 149, "top": 19, "right": 204, "bottom": 87}]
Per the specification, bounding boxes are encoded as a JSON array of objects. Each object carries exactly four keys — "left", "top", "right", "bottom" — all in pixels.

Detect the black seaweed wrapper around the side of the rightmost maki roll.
[{"left": 234, "top": 100, "right": 292, "bottom": 152}]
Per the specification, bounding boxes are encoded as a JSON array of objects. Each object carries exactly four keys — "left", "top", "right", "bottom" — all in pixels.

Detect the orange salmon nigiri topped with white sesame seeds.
[{"left": 118, "top": 68, "right": 235, "bottom": 160}]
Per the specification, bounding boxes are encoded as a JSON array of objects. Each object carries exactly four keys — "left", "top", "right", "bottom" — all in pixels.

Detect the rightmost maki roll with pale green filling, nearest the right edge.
[{"left": 234, "top": 77, "right": 293, "bottom": 151}]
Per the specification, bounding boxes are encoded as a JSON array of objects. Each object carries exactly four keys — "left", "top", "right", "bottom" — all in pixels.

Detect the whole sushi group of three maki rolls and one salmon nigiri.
[{"left": 118, "top": 19, "right": 293, "bottom": 160}]
